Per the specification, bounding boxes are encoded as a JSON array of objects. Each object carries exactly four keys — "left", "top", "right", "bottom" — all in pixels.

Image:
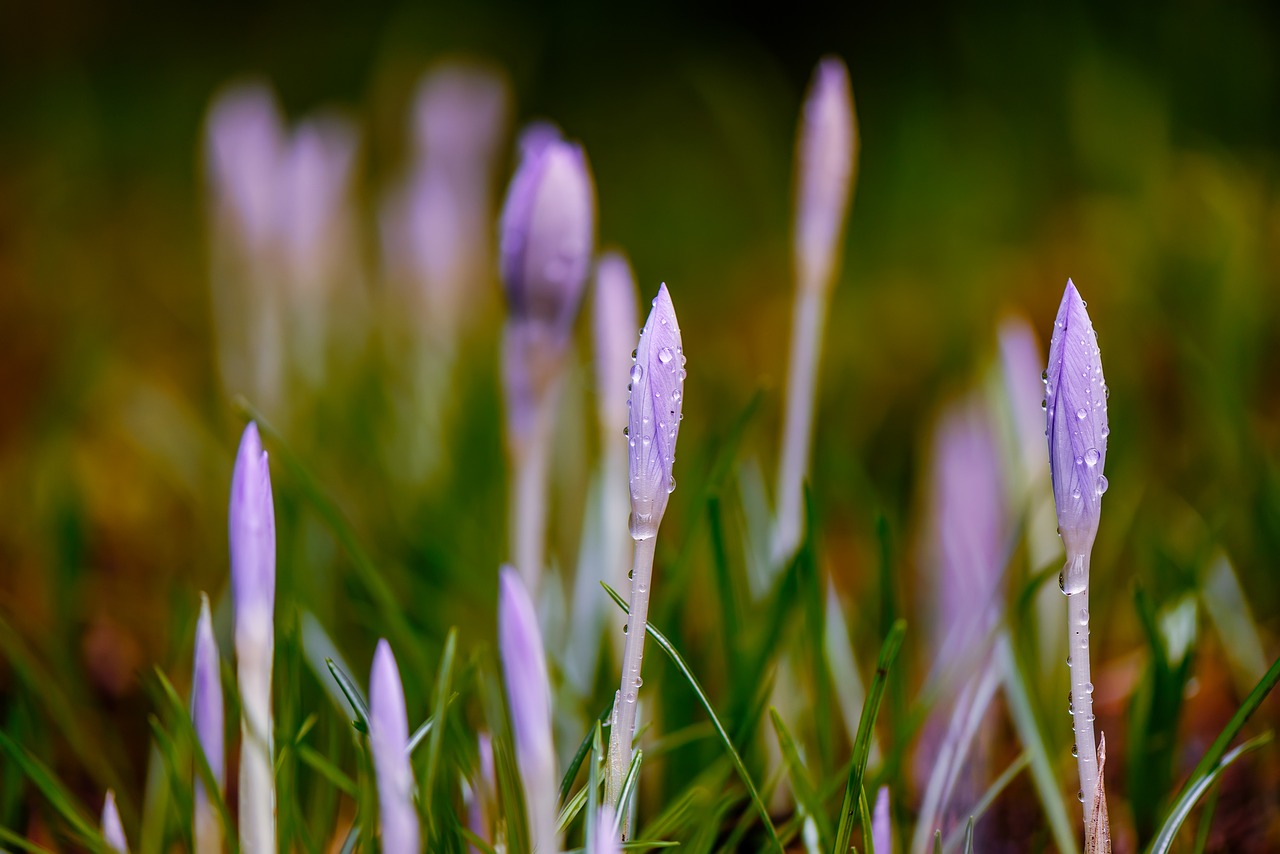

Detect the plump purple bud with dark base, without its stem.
[{"left": 499, "top": 131, "right": 595, "bottom": 338}]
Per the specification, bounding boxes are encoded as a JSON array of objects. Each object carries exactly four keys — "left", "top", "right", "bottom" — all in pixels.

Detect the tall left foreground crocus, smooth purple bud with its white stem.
[{"left": 230, "top": 423, "right": 275, "bottom": 854}]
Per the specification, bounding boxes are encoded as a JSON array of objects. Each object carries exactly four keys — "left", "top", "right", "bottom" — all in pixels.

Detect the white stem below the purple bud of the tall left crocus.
[{"left": 236, "top": 615, "right": 276, "bottom": 854}]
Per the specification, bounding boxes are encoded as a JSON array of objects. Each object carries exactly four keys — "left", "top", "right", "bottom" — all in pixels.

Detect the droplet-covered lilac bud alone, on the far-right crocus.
[{"left": 1044, "top": 279, "right": 1110, "bottom": 563}]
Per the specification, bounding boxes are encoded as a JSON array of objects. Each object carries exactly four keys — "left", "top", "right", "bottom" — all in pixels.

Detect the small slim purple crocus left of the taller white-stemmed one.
[{"left": 191, "top": 593, "right": 227, "bottom": 854}]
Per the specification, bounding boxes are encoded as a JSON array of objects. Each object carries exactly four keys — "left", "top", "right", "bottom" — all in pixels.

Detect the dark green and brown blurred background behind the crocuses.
[{"left": 0, "top": 0, "right": 1280, "bottom": 850}]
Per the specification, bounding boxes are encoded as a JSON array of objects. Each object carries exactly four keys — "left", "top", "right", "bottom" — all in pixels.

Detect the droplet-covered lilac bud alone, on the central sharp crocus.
[{"left": 627, "top": 284, "right": 685, "bottom": 540}]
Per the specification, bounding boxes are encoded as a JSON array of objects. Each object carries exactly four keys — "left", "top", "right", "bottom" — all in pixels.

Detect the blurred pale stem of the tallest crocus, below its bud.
[{"left": 772, "top": 283, "right": 828, "bottom": 565}]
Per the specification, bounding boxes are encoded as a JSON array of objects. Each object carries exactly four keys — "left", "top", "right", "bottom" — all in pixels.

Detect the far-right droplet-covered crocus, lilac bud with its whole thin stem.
[{"left": 1044, "top": 279, "right": 1110, "bottom": 836}]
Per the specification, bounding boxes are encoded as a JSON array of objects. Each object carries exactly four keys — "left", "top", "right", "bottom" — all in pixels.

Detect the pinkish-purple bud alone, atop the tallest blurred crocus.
[{"left": 795, "top": 56, "right": 858, "bottom": 289}]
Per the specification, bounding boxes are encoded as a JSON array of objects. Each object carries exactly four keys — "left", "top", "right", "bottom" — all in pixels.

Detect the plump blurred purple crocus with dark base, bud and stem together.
[{"left": 499, "top": 127, "right": 595, "bottom": 590}]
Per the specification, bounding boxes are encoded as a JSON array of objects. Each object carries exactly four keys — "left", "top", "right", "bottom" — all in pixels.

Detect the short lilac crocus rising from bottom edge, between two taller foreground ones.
[{"left": 369, "top": 640, "right": 421, "bottom": 851}]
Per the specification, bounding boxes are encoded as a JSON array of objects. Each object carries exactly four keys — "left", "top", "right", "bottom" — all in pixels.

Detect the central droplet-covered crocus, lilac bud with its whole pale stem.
[{"left": 607, "top": 284, "right": 685, "bottom": 829}]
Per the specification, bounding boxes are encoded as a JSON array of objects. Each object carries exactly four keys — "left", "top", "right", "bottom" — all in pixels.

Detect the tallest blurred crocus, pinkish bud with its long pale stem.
[{"left": 772, "top": 56, "right": 858, "bottom": 566}]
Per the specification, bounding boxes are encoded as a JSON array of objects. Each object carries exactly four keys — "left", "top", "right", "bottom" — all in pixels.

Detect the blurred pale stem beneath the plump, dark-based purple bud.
[{"left": 511, "top": 391, "right": 559, "bottom": 599}]
